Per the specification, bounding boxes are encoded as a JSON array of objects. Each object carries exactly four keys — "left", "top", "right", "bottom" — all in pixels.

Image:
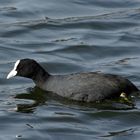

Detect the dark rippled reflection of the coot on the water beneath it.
[{"left": 15, "top": 87, "right": 135, "bottom": 113}]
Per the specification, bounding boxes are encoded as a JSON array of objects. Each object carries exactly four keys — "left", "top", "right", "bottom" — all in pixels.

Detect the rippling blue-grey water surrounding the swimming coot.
[{"left": 0, "top": 0, "right": 140, "bottom": 140}]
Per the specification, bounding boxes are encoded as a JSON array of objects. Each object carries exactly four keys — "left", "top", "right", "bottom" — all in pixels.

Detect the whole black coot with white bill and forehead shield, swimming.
[{"left": 7, "top": 59, "right": 139, "bottom": 102}]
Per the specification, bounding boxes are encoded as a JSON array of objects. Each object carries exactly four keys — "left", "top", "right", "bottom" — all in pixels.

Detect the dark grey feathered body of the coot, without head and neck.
[{"left": 42, "top": 72, "right": 138, "bottom": 102}]
